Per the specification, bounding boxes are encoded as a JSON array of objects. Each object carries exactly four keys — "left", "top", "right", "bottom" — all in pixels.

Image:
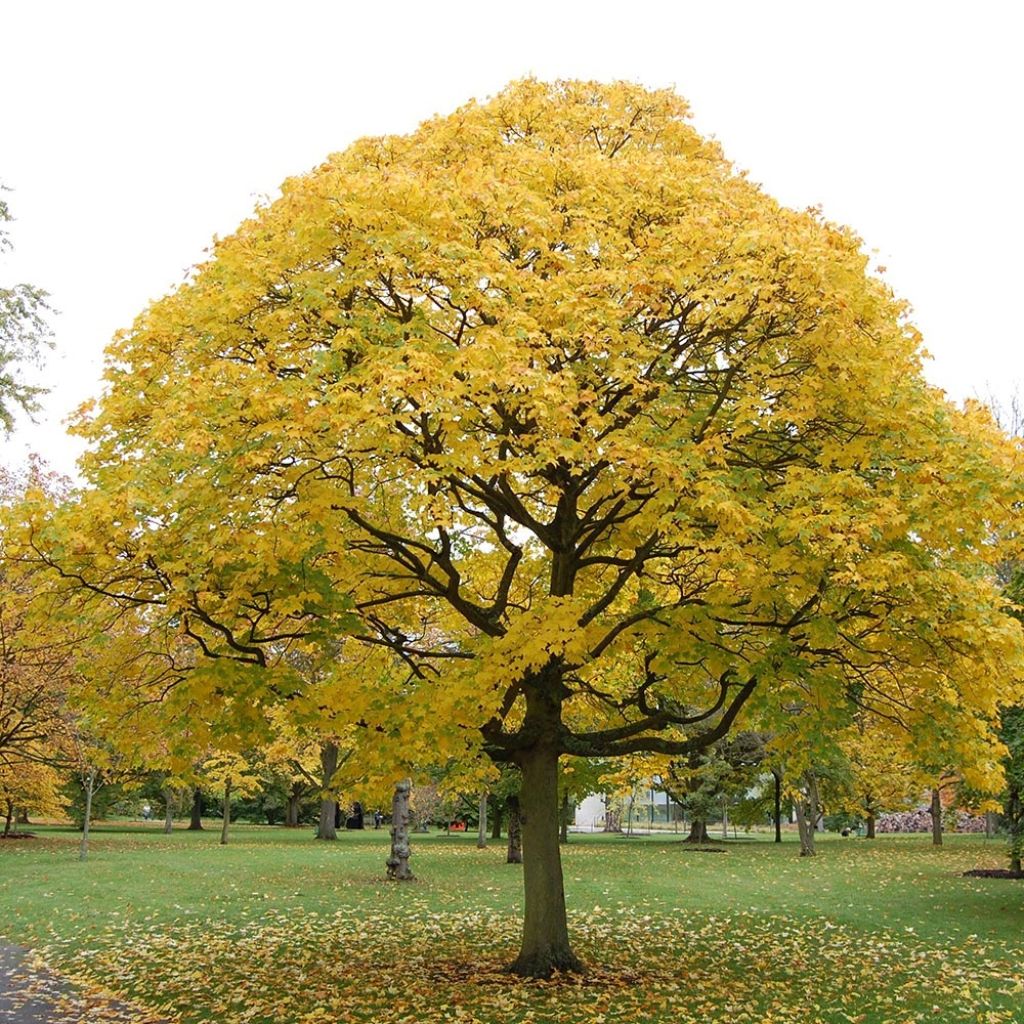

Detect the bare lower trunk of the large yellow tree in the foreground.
[{"left": 509, "top": 745, "right": 582, "bottom": 978}]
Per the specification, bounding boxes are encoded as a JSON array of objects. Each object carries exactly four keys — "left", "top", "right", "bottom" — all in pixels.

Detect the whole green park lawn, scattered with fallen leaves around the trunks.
[{"left": 0, "top": 823, "right": 1024, "bottom": 1024}]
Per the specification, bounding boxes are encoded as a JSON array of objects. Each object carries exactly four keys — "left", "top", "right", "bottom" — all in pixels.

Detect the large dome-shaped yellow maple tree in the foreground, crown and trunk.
[{"left": 25, "top": 80, "right": 1021, "bottom": 975}]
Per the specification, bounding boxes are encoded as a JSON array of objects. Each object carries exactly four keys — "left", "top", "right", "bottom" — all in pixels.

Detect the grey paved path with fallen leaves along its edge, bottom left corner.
[{"left": 0, "top": 942, "right": 158, "bottom": 1024}]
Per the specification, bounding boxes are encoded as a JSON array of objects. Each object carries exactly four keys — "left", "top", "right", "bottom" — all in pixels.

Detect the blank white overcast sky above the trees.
[{"left": 0, "top": 0, "right": 1024, "bottom": 472}]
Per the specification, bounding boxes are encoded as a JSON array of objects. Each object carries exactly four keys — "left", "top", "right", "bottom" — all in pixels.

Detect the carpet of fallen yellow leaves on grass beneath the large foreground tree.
[{"left": 34, "top": 895, "right": 1024, "bottom": 1024}]
